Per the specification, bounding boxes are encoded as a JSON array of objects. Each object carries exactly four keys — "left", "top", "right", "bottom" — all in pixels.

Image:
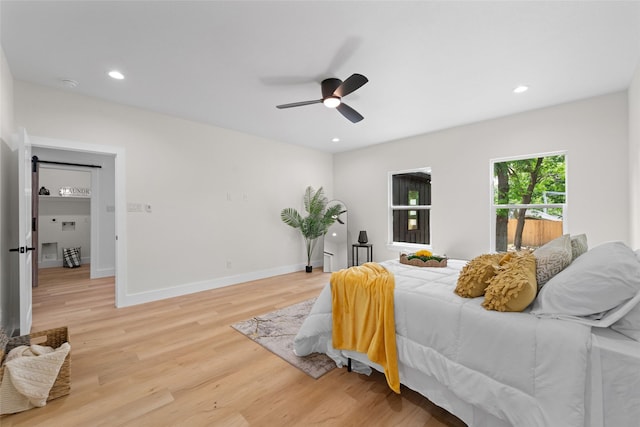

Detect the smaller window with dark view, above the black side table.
[{"left": 389, "top": 168, "right": 431, "bottom": 246}]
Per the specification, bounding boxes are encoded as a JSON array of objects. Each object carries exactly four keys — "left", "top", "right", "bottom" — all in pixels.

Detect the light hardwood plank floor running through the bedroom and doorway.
[{"left": 0, "top": 265, "right": 464, "bottom": 427}]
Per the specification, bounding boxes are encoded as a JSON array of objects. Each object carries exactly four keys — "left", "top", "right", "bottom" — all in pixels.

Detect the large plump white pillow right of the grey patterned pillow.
[{"left": 531, "top": 242, "right": 640, "bottom": 327}]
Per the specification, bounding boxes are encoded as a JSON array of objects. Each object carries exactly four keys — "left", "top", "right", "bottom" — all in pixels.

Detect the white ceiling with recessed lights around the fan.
[{"left": 0, "top": 0, "right": 640, "bottom": 152}]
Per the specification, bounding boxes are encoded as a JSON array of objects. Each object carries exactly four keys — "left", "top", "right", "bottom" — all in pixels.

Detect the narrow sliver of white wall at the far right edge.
[{"left": 629, "top": 64, "right": 640, "bottom": 248}]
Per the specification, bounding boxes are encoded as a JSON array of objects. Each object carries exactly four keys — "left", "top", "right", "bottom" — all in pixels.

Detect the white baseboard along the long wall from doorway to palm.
[{"left": 118, "top": 262, "right": 322, "bottom": 307}]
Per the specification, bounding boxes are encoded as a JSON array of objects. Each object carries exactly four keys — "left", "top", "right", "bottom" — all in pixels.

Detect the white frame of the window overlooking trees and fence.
[{"left": 489, "top": 150, "right": 569, "bottom": 252}]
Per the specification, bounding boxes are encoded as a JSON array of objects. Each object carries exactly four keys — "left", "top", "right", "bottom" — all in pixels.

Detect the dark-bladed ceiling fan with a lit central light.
[{"left": 276, "top": 74, "right": 369, "bottom": 123}]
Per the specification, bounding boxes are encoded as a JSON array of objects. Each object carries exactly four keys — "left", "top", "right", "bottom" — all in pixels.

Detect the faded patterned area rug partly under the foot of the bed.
[{"left": 231, "top": 298, "right": 336, "bottom": 379}]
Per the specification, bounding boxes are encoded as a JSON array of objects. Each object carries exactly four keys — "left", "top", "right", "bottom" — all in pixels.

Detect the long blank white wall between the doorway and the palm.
[{"left": 14, "top": 81, "right": 333, "bottom": 302}]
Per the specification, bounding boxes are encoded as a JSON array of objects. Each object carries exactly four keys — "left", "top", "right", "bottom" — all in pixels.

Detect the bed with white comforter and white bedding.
[{"left": 294, "top": 239, "right": 640, "bottom": 427}]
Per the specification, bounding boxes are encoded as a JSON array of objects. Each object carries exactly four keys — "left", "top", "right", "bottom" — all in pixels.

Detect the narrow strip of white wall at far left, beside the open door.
[{"left": 0, "top": 49, "right": 20, "bottom": 334}]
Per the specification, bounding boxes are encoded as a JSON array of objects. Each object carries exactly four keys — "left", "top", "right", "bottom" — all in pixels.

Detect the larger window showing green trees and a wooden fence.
[{"left": 491, "top": 153, "right": 567, "bottom": 251}]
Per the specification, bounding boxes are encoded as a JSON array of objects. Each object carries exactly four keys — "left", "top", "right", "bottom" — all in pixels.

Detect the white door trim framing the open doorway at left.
[{"left": 30, "top": 136, "right": 127, "bottom": 307}]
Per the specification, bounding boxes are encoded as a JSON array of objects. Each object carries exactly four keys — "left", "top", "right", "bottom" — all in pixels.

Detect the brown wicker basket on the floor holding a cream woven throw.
[{"left": 0, "top": 326, "right": 71, "bottom": 401}]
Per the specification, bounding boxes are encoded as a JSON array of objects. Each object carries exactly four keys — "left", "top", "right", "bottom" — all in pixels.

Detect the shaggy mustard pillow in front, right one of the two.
[{"left": 482, "top": 252, "right": 538, "bottom": 311}]
